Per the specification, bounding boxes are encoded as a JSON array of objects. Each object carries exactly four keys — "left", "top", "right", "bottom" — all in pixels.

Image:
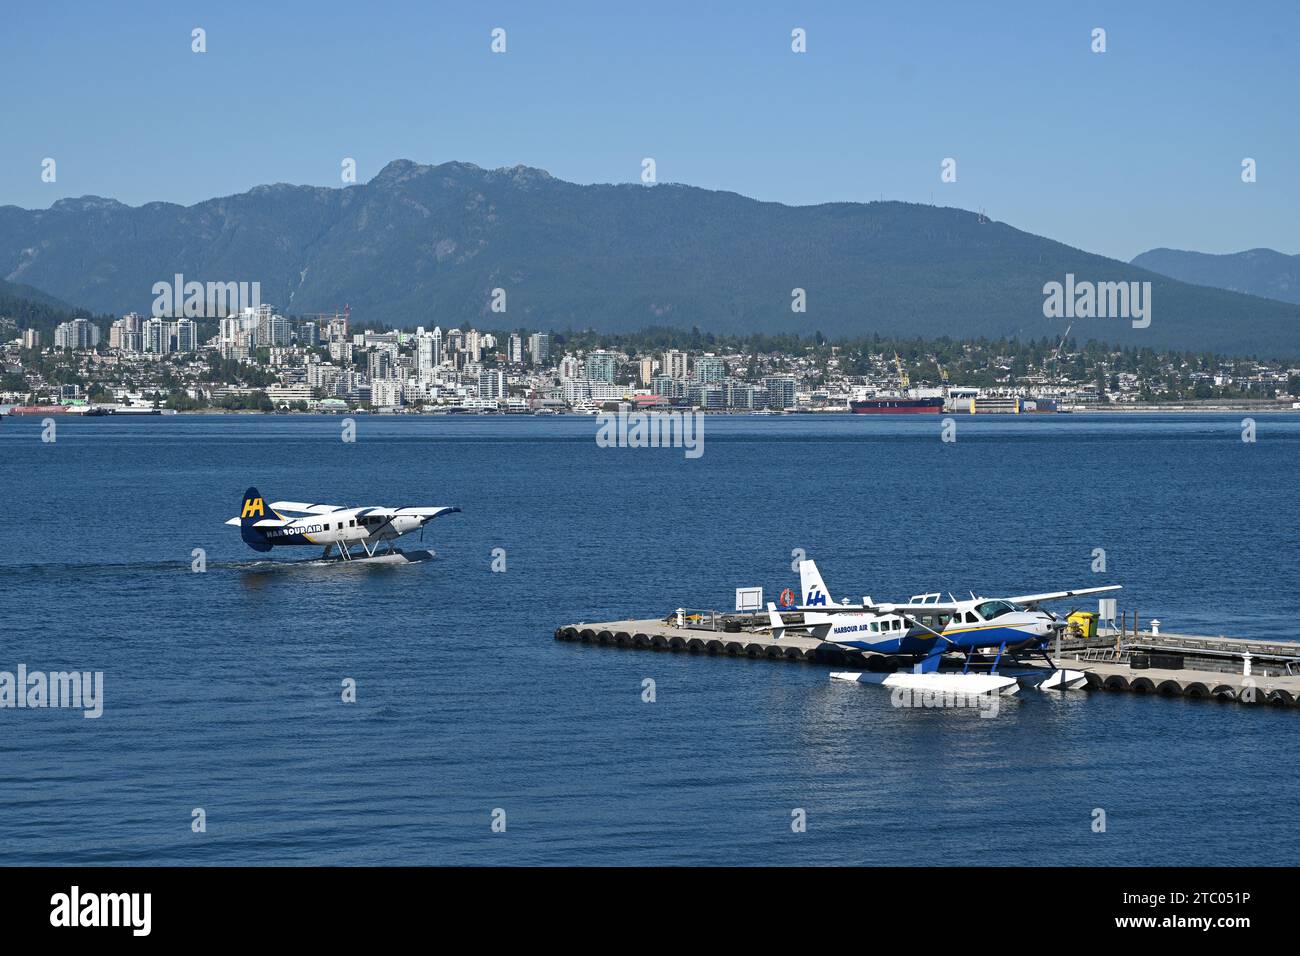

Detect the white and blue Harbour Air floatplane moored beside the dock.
[{"left": 762, "top": 561, "right": 1122, "bottom": 695}]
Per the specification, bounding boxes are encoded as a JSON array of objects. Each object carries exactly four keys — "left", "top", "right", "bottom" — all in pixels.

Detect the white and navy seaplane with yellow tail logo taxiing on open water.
[{"left": 226, "top": 488, "right": 460, "bottom": 563}]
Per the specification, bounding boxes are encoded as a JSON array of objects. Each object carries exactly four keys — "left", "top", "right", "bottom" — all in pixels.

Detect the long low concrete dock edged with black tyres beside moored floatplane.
[{"left": 555, "top": 611, "right": 1300, "bottom": 708}]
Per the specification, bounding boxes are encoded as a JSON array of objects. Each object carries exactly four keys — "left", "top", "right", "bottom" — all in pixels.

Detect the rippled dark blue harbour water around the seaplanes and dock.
[{"left": 0, "top": 415, "right": 1300, "bottom": 865}]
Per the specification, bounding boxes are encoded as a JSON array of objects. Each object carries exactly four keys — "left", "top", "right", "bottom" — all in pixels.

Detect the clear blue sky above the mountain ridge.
[{"left": 0, "top": 0, "right": 1300, "bottom": 259}]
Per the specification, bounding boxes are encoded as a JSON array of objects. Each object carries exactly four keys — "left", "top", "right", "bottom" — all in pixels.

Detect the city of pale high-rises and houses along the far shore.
[{"left": 12, "top": 303, "right": 1300, "bottom": 415}]
